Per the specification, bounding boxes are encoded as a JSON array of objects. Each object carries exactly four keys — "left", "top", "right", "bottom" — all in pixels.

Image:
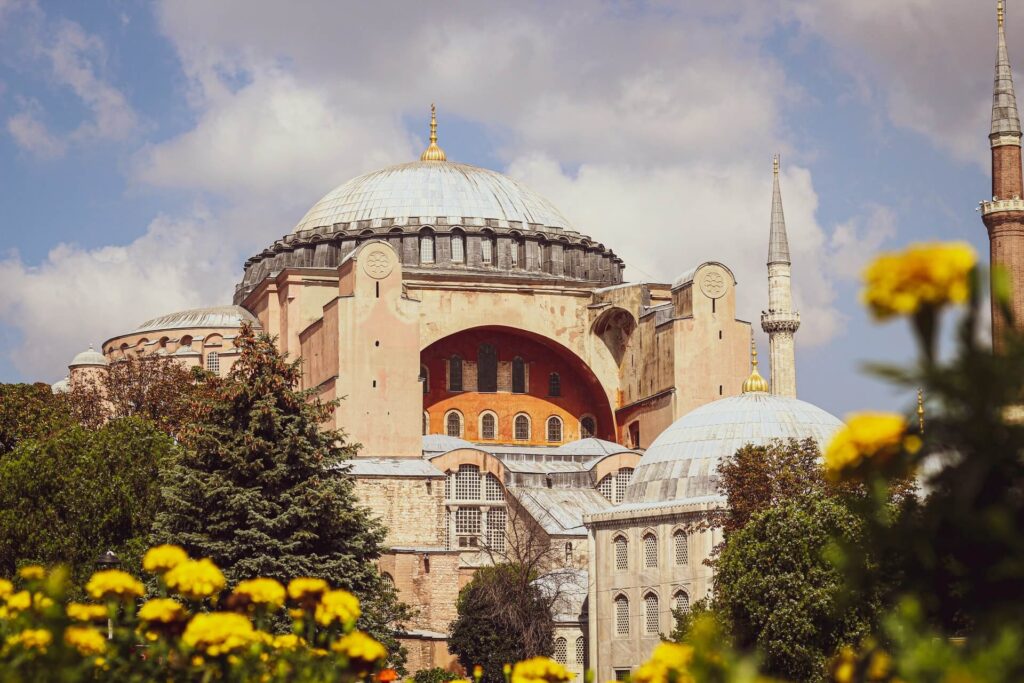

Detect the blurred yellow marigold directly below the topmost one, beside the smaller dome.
[{"left": 824, "top": 413, "right": 921, "bottom": 478}]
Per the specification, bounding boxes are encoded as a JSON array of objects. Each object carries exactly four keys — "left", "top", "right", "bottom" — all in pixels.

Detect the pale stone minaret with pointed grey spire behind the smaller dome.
[{"left": 761, "top": 155, "right": 800, "bottom": 398}]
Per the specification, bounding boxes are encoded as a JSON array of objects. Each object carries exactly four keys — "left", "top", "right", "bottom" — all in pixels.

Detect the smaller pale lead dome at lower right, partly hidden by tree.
[{"left": 626, "top": 391, "right": 843, "bottom": 503}]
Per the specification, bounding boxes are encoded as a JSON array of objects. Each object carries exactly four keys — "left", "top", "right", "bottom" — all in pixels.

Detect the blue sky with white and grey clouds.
[{"left": 0, "top": 0, "right": 1007, "bottom": 417}]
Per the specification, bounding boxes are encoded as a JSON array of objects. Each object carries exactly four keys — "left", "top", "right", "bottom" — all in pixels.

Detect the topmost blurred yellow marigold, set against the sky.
[{"left": 862, "top": 242, "right": 977, "bottom": 319}]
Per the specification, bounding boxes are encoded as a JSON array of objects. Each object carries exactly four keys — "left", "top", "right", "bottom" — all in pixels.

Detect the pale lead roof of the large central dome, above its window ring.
[{"left": 295, "top": 161, "right": 571, "bottom": 232}]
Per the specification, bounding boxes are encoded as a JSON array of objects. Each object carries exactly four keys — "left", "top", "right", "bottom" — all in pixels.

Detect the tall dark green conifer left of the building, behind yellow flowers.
[{"left": 154, "top": 326, "right": 410, "bottom": 664}]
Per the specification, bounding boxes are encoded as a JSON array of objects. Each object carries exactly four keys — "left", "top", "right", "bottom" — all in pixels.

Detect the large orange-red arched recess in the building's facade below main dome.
[{"left": 420, "top": 325, "right": 617, "bottom": 445}]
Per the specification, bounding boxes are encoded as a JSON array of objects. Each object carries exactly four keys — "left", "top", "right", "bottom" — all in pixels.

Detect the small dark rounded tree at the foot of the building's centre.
[{"left": 449, "top": 563, "right": 553, "bottom": 683}]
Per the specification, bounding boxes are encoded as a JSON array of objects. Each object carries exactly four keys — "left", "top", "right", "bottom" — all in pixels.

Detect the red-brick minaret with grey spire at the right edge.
[{"left": 981, "top": 0, "right": 1024, "bottom": 351}]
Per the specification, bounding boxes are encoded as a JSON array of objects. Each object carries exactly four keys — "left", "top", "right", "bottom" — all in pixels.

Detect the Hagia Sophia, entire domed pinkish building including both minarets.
[{"left": 54, "top": 3, "right": 1024, "bottom": 681}]
